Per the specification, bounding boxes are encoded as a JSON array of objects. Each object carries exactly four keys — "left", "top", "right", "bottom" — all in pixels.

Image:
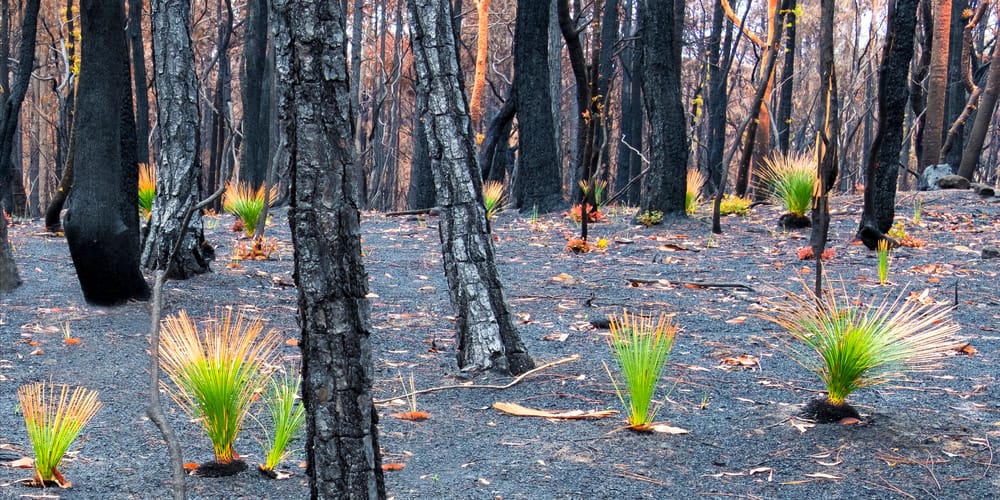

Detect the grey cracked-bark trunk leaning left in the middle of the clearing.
[{"left": 407, "top": 0, "right": 536, "bottom": 374}]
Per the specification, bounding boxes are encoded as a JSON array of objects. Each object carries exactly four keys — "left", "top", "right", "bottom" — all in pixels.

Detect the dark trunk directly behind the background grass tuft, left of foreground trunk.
[{"left": 240, "top": 0, "right": 271, "bottom": 189}]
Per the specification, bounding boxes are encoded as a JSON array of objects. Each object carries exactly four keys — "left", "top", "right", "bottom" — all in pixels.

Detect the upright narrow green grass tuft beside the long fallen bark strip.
[{"left": 604, "top": 310, "right": 677, "bottom": 430}]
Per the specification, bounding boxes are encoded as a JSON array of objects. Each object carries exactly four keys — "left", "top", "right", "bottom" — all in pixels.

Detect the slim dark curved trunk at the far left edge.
[{"left": 0, "top": 0, "right": 40, "bottom": 213}]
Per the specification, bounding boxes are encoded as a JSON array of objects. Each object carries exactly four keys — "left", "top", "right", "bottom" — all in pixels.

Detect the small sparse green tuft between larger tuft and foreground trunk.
[{"left": 262, "top": 373, "right": 306, "bottom": 471}]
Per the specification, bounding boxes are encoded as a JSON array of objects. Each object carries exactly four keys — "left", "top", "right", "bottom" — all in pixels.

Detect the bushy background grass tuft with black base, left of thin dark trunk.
[{"left": 760, "top": 153, "right": 816, "bottom": 217}]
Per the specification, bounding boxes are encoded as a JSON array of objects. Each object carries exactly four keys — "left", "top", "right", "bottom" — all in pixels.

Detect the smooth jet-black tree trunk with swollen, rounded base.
[{"left": 64, "top": 0, "right": 149, "bottom": 305}]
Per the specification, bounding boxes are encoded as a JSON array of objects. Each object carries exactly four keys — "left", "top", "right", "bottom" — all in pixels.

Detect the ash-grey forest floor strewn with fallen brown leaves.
[{"left": 0, "top": 191, "right": 1000, "bottom": 499}]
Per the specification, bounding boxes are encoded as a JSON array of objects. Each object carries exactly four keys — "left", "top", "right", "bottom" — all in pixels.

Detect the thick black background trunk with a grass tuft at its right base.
[{"left": 639, "top": 0, "right": 688, "bottom": 215}]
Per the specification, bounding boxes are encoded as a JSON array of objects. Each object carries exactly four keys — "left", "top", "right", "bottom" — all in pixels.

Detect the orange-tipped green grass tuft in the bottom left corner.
[{"left": 17, "top": 382, "right": 101, "bottom": 486}]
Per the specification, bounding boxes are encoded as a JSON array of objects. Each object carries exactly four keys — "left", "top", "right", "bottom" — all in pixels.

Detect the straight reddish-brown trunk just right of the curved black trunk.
[{"left": 918, "top": 0, "right": 951, "bottom": 173}]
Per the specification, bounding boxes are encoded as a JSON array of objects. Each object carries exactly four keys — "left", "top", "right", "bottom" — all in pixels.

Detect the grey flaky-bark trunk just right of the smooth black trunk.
[{"left": 142, "top": 0, "right": 213, "bottom": 279}]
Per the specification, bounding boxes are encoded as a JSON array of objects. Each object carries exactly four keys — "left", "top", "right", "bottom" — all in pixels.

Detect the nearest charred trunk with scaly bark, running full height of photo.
[{"left": 272, "top": 0, "right": 385, "bottom": 499}]
